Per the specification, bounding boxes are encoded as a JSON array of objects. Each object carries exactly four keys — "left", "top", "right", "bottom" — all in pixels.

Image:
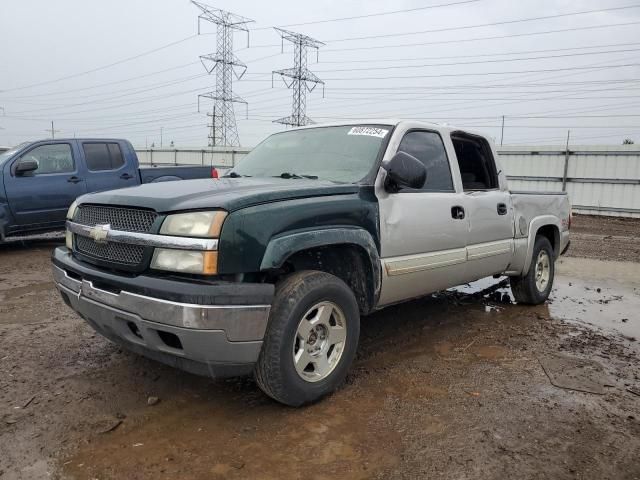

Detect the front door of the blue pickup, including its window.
[{"left": 5, "top": 142, "right": 86, "bottom": 229}]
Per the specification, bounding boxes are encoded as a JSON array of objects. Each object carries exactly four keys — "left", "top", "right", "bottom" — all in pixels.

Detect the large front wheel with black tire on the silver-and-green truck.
[{"left": 254, "top": 270, "right": 360, "bottom": 407}]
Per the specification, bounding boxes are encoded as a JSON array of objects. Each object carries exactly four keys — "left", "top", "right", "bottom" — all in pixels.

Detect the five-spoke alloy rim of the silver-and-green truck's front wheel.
[{"left": 293, "top": 302, "right": 347, "bottom": 382}]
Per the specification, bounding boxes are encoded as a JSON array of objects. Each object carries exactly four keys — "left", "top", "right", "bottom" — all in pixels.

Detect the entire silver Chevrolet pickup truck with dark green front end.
[{"left": 53, "top": 121, "right": 570, "bottom": 405}]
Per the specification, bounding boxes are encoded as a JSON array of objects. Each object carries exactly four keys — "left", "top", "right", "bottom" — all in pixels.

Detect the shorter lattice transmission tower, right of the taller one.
[{"left": 271, "top": 27, "right": 324, "bottom": 127}]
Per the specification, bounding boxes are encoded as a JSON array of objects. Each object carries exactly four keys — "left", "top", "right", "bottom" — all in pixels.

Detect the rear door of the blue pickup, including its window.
[{"left": 81, "top": 142, "right": 138, "bottom": 192}]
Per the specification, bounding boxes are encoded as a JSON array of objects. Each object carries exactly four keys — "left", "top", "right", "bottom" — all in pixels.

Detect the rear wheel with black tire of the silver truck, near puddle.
[{"left": 509, "top": 235, "right": 555, "bottom": 305}]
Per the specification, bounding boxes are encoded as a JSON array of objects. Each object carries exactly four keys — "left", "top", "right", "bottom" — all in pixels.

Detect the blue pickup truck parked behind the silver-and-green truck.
[{"left": 0, "top": 138, "right": 216, "bottom": 242}]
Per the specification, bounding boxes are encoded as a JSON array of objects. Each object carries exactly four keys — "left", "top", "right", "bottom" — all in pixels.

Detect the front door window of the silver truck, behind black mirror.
[{"left": 398, "top": 130, "right": 453, "bottom": 192}]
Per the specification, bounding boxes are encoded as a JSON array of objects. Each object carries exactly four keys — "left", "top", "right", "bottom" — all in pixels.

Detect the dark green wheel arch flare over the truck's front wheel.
[{"left": 260, "top": 227, "right": 382, "bottom": 314}]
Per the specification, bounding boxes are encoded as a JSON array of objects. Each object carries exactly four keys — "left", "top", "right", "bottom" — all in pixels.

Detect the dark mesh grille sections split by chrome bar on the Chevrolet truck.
[{"left": 73, "top": 205, "right": 158, "bottom": 267}]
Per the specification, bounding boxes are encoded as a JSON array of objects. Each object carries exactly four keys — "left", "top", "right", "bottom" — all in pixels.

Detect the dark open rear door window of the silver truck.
[{"left": 451, "top": 133, "right": 498, "bottom": 191}]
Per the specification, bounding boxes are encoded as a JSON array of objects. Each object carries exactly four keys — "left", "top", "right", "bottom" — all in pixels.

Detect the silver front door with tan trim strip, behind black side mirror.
[{"left": 376, "top": 129, "right": 468, "bottom": 305}]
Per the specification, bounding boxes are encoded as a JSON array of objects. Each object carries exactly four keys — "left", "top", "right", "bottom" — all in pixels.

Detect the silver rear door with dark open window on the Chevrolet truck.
[{"left": 451, "top": 132, "right": 514, "bottom": 281}]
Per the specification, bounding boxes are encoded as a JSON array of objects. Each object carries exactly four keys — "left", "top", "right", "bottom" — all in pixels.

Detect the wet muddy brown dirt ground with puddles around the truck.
[{"left": 0, "top": 216, "right": 640, "bottom": 480}]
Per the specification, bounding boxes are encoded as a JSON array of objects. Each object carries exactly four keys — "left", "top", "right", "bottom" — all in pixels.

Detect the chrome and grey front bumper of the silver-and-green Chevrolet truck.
[{"left": 53, "top": 249, "right": 270, "bottom": 377}]
